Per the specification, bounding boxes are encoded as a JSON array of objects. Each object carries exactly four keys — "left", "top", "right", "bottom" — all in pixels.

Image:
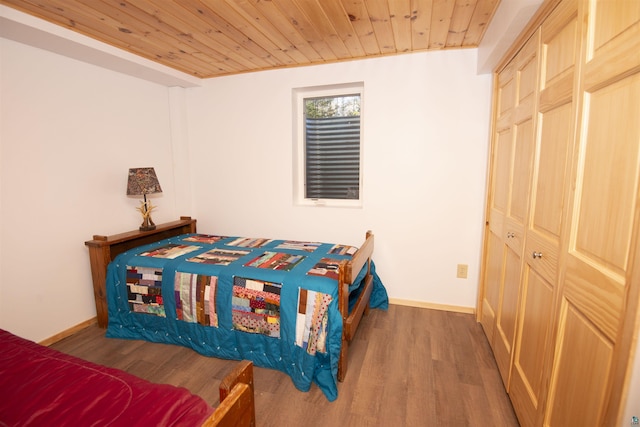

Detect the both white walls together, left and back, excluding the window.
[{"left": 0, "top": 32, "right": 490, "bottom": 341}]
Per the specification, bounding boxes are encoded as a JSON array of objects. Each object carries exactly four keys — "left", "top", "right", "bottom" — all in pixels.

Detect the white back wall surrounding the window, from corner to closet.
[{"left": 187, "top": 50, "right": 491, "bottom": 308}]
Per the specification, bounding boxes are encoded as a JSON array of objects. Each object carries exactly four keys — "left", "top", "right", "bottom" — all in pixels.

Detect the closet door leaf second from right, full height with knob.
[{"left": 510, "top": 0, "right": 580, "bottom": 427}]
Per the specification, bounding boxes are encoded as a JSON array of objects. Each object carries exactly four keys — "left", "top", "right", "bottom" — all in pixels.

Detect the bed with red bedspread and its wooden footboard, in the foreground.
[{"left": 0, "top": 329, "right": 256, "bottom": 427}]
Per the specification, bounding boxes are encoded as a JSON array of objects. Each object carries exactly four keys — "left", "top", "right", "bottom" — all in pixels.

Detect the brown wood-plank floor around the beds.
[{"left": 51, "top": 305, "right": 518, "bottom": 427}]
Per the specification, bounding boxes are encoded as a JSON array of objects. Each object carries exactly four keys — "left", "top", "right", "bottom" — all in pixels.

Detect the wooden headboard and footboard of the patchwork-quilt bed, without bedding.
[{"left": 85, "top": 216, "right": 374, "bottom": 381}]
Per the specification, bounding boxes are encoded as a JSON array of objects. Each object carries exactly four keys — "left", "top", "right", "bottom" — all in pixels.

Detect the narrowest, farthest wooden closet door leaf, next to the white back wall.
[{"left": 480, "top": 62, "right": 516, "bottom": 344}]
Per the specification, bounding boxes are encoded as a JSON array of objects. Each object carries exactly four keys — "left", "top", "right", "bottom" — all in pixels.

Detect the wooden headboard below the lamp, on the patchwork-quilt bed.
[{"left": 84, "top": 216, "right": 196, "bottom": 328}]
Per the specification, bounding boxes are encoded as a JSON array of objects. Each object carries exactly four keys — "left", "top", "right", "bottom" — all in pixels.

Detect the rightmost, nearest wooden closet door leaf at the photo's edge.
[{"left": 544, "top": 0, "right": 640, "bottom": 426}]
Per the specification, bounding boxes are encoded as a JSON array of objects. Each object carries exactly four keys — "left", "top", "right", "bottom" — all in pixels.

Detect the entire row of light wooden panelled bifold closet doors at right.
[{"left": 478, "top": 0, "right": 640, "bottom": 426}]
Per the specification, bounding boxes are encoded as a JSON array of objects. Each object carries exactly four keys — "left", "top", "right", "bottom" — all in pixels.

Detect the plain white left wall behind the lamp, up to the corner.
[{"left": 0, "top": 39, "right": 182, "bottom": 341}]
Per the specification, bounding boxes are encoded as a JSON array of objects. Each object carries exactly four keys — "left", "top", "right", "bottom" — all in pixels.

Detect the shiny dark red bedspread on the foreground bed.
[{"left": 0, "top": 330, "right": 213, "bottom": 426}]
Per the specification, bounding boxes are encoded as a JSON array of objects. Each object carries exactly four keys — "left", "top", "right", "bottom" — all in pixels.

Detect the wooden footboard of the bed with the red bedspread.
[{"left": 202, "top": 360, "right": 256, "bottom": 427}]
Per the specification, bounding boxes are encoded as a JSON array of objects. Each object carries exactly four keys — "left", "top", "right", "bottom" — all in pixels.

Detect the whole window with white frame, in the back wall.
[{"left": 294, "top": 83, "right": 363, "bottom": 207}]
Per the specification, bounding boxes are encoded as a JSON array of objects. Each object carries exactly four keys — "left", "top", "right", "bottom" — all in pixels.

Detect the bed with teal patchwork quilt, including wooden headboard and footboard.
[{"left": 86, "top": 217, "right": 388, "bottom": 401}]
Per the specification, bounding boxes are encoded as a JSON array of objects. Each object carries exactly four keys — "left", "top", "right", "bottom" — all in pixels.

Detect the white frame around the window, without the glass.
[{"left": 293, "top": 82, "right": 364, "bottom": 208}]
